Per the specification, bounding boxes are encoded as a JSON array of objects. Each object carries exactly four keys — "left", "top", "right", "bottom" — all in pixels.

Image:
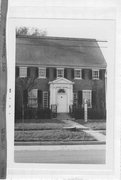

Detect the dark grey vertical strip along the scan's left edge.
[{"left": 0, "top": 0, "right": 8, "bottom": 179}]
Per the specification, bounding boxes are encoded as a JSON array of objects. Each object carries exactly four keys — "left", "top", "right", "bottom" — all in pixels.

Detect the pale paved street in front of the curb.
[{"left": 14, "top": 145, "right": 106, "bottom": 164}]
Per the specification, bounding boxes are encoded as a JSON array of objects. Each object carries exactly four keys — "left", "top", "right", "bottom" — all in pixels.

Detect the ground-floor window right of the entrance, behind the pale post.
[{"left": 82, "top": 90, "right": 92, "bottom": 108}]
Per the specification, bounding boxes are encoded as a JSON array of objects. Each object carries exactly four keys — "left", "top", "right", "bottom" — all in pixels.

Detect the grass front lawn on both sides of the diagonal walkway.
[{"left": 15, "top": 119, "right": 106, "bottom": 144}]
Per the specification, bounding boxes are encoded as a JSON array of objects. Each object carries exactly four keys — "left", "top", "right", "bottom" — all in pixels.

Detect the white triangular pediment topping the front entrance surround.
[{"left": 49, "top": 77, "right": 74, "bottom": 84}]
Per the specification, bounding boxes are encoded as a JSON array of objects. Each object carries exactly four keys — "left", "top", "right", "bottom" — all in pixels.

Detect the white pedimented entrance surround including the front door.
[{"left": 49, "top": 77, "right": 74, "bottom": 113}]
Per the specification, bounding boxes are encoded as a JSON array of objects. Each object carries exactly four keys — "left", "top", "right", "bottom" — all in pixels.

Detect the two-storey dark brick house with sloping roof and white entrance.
[{"left": 16, "top": 36, "right": 106, "bottom": 119}]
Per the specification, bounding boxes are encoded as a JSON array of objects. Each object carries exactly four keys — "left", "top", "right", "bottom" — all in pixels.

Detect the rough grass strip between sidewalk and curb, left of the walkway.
[{"left": 15, "top": 129, "right": 96, "bottom": 142}]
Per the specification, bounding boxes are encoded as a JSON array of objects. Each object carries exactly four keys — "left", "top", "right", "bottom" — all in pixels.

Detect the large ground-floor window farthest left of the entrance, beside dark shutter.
[{"left": 28, "top": 89, "right": 38, "bottom": 108}]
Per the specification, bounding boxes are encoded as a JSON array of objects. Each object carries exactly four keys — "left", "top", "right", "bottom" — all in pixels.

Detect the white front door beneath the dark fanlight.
[{"left": 57, "top": 93, "right": 68, "bottom": 113}]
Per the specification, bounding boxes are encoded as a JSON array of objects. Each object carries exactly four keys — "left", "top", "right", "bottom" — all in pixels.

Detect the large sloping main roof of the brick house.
[{"left": 16, "top": 36, "right": 106, "bottom": 68}]
